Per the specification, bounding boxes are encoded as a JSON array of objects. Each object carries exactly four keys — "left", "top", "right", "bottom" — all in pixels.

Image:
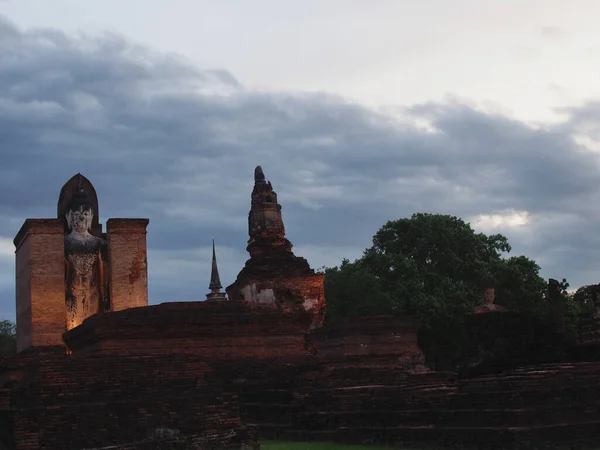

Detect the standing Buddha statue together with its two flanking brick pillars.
[{"left": 14, "top": 173, "right": 149, "bottom": 352}]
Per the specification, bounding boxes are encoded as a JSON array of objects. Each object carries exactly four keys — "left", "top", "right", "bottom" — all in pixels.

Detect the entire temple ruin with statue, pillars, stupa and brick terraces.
[{"left": 0, "top": 170, "right": 600, "bottom": 450}]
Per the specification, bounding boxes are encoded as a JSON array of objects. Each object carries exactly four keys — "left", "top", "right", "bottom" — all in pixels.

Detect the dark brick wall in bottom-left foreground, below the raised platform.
[{"left": 3, "top": 355, "right": 258, "bottom": 450}]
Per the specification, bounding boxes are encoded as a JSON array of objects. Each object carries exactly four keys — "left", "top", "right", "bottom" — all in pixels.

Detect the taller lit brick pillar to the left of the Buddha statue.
[{"left": 14, "top": 219, "right": 66, "bottom": 352}]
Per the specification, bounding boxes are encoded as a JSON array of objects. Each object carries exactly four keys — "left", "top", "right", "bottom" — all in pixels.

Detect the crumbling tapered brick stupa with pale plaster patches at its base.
[{"left": 226, "top": 166, "right": 326, "bottom": 328}]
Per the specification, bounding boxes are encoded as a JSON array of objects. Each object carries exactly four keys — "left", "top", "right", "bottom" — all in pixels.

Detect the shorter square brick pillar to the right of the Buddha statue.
[{"left": 106, "top": 219, "right": 149, "bottom": 311}]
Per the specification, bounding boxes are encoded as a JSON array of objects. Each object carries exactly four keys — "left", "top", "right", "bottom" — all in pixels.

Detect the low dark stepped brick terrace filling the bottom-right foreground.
[{"left": 244, "top": 363, "right": 600, "bottom": 449}]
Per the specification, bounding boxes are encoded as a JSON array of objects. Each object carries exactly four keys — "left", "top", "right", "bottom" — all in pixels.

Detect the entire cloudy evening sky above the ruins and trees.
[{"left": 0, "top": 0, "right": 600, "bottom": 319}]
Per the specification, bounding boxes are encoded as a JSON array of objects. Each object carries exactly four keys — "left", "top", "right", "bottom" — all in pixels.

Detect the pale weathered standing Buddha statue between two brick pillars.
[{"left": 65, "top": 189, "right": 108, "bottom": 331}]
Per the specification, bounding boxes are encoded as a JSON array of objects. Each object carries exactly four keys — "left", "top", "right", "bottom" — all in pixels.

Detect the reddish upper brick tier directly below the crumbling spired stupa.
[{"left": 64, "top": 301, "right": 311, "bottom": 358}]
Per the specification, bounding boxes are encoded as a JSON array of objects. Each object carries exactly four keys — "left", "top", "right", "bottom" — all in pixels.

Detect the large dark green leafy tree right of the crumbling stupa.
[{"left": 325, "top": 214, "right": 547, "bottom": 368}]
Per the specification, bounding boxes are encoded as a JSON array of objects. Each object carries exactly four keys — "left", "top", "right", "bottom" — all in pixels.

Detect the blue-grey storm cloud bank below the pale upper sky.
[{"left": 0, "top": 16, "right": 600, "bottom": 320}]
